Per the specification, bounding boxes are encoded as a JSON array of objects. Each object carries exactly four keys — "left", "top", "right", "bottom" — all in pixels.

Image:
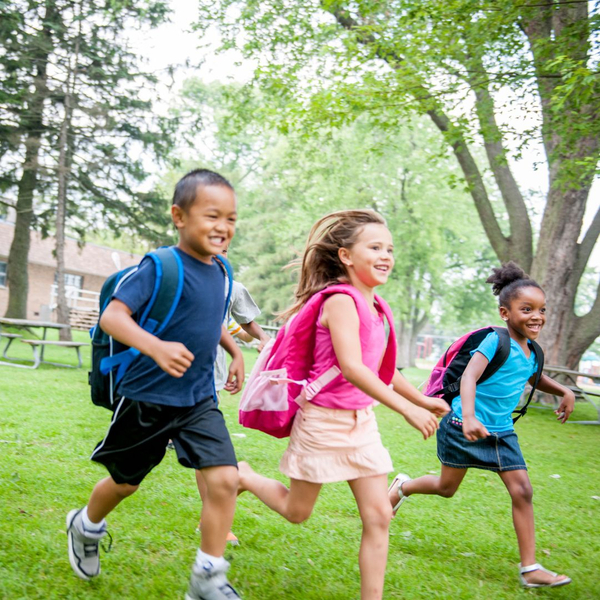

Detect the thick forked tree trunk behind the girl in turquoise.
[{"left": 328, "top": 2, "right": 600, "bottom": 368}]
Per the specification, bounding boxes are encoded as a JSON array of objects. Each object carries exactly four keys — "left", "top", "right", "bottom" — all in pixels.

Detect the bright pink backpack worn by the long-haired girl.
[{"left": 239, "top": 284, "right": 396, "bottom": 438}]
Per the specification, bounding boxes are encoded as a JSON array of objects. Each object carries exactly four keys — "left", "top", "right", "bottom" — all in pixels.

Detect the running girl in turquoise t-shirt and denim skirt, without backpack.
[{"left": 390, "top": 262, "right": 575, "bottom": 588}]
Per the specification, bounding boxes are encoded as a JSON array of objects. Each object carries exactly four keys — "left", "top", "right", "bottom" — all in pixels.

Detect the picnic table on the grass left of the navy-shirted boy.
[{"left": 0, "top": 317, "right": 87, "bottom": 369}]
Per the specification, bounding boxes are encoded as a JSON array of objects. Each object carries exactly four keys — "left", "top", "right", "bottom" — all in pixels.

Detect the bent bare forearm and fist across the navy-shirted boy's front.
[{"left": 100, "top": 300, "right": 194, "bottom": 377}]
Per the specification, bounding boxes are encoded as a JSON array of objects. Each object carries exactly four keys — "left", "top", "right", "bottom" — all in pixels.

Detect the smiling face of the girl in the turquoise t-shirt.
[{"left": 499, "top": 286, "right": 546, "bottom": 340}]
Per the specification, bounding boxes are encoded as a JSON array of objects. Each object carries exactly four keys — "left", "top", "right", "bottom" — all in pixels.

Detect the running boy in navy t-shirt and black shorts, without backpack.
[{"left": 67, "top": 169, "right": 244, "bottom": 600}]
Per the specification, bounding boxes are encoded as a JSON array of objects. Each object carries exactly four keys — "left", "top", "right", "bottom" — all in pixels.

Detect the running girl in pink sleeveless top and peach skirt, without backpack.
[{"left": 239, "top": 210, "right": 448, "bottom": 600}]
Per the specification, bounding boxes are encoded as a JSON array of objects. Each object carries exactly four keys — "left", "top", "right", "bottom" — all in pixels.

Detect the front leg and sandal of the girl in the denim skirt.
[{"left": 498, "top": 469, "right": 566, "bottom": 583}]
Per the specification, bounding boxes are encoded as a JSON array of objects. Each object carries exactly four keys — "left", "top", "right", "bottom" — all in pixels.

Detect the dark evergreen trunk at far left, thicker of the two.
[{"left": 6, "top": 1, "right": 57, "bottom": 319}]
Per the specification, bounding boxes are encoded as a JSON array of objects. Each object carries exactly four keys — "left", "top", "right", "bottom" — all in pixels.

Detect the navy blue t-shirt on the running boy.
[{"left": 113, "top": 248, "right": 225, "bottom": 406}]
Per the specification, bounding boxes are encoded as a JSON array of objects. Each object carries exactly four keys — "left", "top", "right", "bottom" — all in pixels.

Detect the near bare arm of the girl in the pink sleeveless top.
[{"left": 321, "top": 294, "right": 438, "bottom": 439}]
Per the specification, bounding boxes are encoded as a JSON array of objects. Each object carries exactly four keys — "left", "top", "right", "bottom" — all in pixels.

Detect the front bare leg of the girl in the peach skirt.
[{"left": 348, "top": 475, "right": 392, "bottom": 600}]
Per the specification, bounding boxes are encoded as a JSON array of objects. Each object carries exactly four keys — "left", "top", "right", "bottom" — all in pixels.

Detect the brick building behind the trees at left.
[{"left": 0, "top": 220, "right": 141, "bottom": 320}]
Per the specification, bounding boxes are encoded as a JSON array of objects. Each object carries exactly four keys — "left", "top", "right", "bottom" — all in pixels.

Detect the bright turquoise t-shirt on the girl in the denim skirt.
[{"left": 452, "top": 331, "right": 537, "bottom": 433}]
